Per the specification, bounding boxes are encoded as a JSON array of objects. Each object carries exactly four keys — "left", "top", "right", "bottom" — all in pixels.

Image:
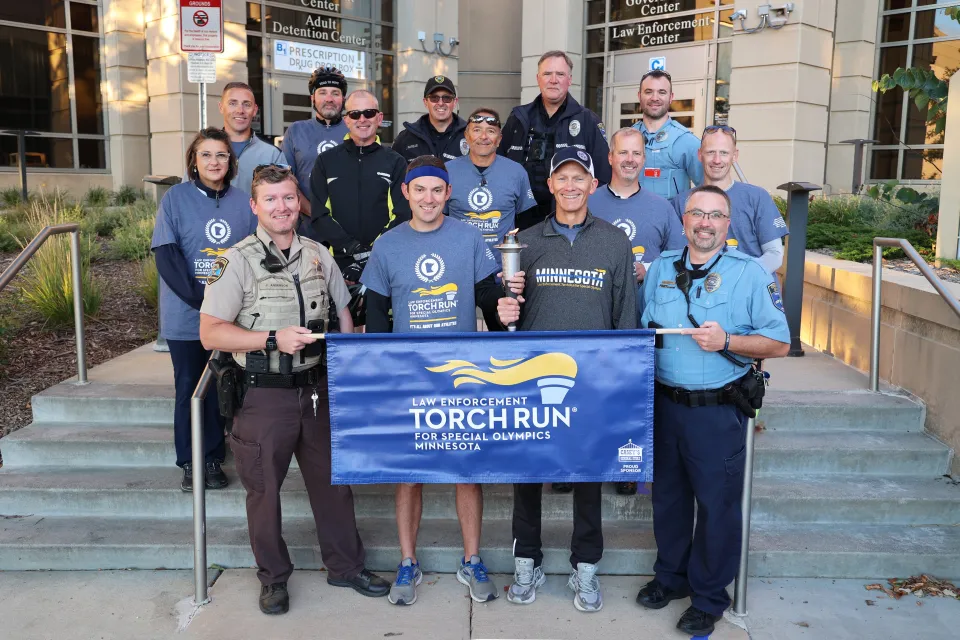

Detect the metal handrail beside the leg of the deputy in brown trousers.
[{"left": 190, "top": 351, "right": 220, "bottom": 606}]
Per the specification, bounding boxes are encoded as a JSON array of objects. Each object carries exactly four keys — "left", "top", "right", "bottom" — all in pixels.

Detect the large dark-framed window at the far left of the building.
[{"left": 0, "top": 0, "right": 107, "bottom": 171}]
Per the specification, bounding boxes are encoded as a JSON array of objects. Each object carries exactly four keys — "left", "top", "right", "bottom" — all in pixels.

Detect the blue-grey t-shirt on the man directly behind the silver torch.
[{"left": 447, "top": 156, "right": 537, "bottom": 266}]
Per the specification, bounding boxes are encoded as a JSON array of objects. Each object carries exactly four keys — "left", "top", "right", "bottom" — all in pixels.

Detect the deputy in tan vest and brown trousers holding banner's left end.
[{"left": 200, "top": 165, "right": 390, "bottom": 614}]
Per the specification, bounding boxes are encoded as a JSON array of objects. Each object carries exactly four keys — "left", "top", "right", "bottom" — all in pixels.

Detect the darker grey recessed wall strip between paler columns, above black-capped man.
[{"left": 457, "top": 0, "right": 523, "bottom": 121}]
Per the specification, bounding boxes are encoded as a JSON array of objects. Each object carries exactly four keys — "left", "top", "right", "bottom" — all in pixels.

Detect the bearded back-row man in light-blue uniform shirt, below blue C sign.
[{"left": 633, "top": 69, "right": 703, "bottom": 199}]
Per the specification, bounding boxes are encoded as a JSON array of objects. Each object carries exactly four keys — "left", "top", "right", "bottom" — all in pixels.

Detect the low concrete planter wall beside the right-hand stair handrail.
[{"left": 800, "top": 252, "right": 960, "bottom": 473}]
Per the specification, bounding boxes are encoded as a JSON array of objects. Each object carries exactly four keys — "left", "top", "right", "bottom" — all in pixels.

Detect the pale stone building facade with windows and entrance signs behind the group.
[{"left": 0, "top": 0, "right": 960, "bottom": 193}]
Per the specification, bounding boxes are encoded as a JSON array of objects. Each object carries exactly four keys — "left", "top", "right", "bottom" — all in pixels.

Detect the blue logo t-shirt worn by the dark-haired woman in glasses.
[{"left": 150, "top": 182, "right": 257, "bottom": 340}]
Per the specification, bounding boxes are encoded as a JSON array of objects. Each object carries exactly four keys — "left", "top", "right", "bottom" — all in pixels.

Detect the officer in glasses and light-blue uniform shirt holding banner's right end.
[{"left": 637, "top": 185, "right": 790, "bottom": 636}]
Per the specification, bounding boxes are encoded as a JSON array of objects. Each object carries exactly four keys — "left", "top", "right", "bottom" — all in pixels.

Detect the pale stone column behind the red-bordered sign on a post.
[{"left": 144, "top": 0, "right": 247, "bottom": 176}]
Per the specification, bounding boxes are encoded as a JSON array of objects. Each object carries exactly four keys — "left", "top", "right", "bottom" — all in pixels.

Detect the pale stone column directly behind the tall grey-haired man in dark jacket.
[{"left": 520, "top": 0, "right": 584, "bottom": 104}]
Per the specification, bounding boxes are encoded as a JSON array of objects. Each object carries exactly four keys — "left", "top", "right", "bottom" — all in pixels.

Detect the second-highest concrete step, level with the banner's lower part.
[{"left": 3, "top": 422, "right": 951, "bottom": 476}]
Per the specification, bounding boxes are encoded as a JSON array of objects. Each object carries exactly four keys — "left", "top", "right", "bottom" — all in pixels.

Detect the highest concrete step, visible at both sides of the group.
[{"left": 33, "top": 382, "right": 924, "bottom": 431}]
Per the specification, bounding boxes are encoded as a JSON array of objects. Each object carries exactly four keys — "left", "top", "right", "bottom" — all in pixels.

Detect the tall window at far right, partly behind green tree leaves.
[{"left": 869, "top": 0, "right": 960, "bottom": 181}]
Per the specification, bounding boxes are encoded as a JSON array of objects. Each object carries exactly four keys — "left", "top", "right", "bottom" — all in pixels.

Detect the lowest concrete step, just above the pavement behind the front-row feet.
[{"left": 0, "top": 516, "right": 960, "bottom": 586}]
